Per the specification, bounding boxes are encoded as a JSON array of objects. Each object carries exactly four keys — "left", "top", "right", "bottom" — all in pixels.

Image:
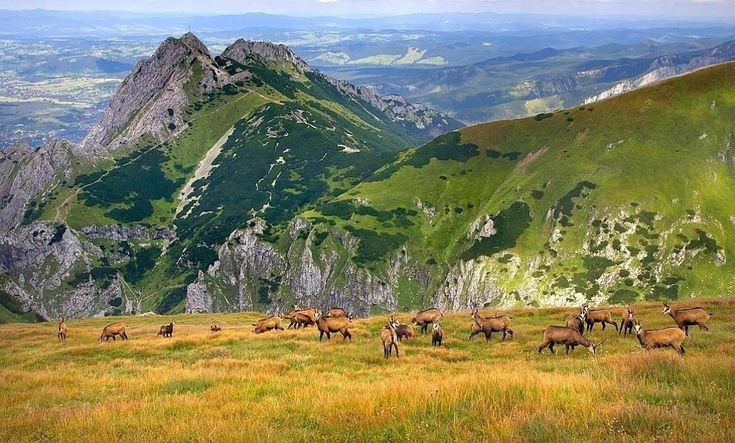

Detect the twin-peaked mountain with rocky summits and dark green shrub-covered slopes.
[{"left": 0, "top": 34, "right": 460, "bottom": 317}]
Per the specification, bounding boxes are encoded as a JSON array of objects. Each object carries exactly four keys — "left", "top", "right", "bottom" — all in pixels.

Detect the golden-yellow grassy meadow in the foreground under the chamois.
[{"left": 0, "top": 298, "right": 735, "bottom": 441}]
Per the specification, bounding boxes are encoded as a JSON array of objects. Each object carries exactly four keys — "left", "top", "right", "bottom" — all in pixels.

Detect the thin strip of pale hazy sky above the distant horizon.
[{"left": 0, "top": 0, "right": 735, "bottom": 19}]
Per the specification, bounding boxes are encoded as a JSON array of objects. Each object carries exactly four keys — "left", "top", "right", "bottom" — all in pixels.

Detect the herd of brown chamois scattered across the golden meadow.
[{"left": 57, "top": 302, "right": 713, "bottom": 358}]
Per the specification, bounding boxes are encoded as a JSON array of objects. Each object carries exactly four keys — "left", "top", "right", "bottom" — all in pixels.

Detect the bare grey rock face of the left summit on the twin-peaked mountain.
[{"left": 76, "top": 33, "right": 231, "bottom": 156}]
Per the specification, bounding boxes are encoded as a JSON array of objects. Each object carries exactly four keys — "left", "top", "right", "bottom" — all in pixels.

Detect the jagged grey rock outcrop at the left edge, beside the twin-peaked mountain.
[{"left": 0, "top": 140, "right": 72, "bottom": 235}]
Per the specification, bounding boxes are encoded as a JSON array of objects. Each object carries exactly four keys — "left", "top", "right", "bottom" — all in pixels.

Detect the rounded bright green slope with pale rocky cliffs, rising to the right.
[{"left": 188, "top": 60, "right": 735, "bottom": 312}]
